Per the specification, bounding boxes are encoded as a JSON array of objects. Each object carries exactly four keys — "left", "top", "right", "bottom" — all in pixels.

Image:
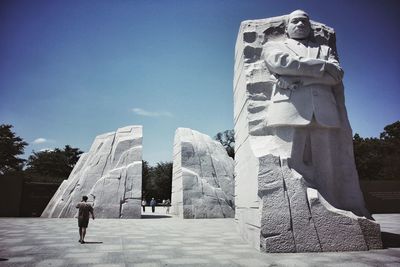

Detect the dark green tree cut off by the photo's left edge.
[{"left": 0, "top": 124, "right": 28, "bottom": 175}]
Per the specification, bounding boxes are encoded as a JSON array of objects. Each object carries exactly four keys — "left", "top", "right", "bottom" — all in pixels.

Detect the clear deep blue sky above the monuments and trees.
[{"left": 0, "top": 0, "right": 400, "bottom": 164}]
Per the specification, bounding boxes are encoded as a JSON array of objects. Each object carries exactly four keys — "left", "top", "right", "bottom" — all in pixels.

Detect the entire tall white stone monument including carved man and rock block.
[{"left": 234, "top": 10, "right": 382, "bottom": 252}]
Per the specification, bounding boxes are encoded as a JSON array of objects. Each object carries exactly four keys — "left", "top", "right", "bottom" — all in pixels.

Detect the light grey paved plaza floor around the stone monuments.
[{"left": 0, "top": 210, "right": 400, "bottom": 267}]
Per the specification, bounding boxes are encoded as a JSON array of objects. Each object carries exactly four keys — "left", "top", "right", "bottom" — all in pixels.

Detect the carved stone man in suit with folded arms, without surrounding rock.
[{"left": 262, "top": 10, "right": 352, "bottom": 215}]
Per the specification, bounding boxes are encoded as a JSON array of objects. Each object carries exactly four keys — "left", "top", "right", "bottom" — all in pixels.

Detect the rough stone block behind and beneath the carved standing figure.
[{"left": 234, "top": 16, "right": 382, "bottom": 252}]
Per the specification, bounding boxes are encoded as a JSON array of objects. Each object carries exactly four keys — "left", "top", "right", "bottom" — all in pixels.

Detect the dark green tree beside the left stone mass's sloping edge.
[{"left": 26, "top": 145, "right": 83, "bottom": 182}]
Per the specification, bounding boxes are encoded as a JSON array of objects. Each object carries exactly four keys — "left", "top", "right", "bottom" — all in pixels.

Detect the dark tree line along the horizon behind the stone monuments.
[{"left": 0, "top": 121, "right": 400, "bottom": 187}]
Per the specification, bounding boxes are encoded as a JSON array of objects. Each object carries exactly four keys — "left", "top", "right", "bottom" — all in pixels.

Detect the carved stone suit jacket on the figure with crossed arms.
[{"left": 262, "top": 39, "right": 343, "bottom": 127}]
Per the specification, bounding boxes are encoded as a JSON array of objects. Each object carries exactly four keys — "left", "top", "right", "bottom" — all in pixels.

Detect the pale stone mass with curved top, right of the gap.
[{"left": 171, "top": 128, "right": 234, "bottom": 219}]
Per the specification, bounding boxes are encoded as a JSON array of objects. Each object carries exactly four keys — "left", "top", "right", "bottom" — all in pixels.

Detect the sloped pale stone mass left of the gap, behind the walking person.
[{"left": 42, "top": 126, "right": 142, "bottom": 218}]
